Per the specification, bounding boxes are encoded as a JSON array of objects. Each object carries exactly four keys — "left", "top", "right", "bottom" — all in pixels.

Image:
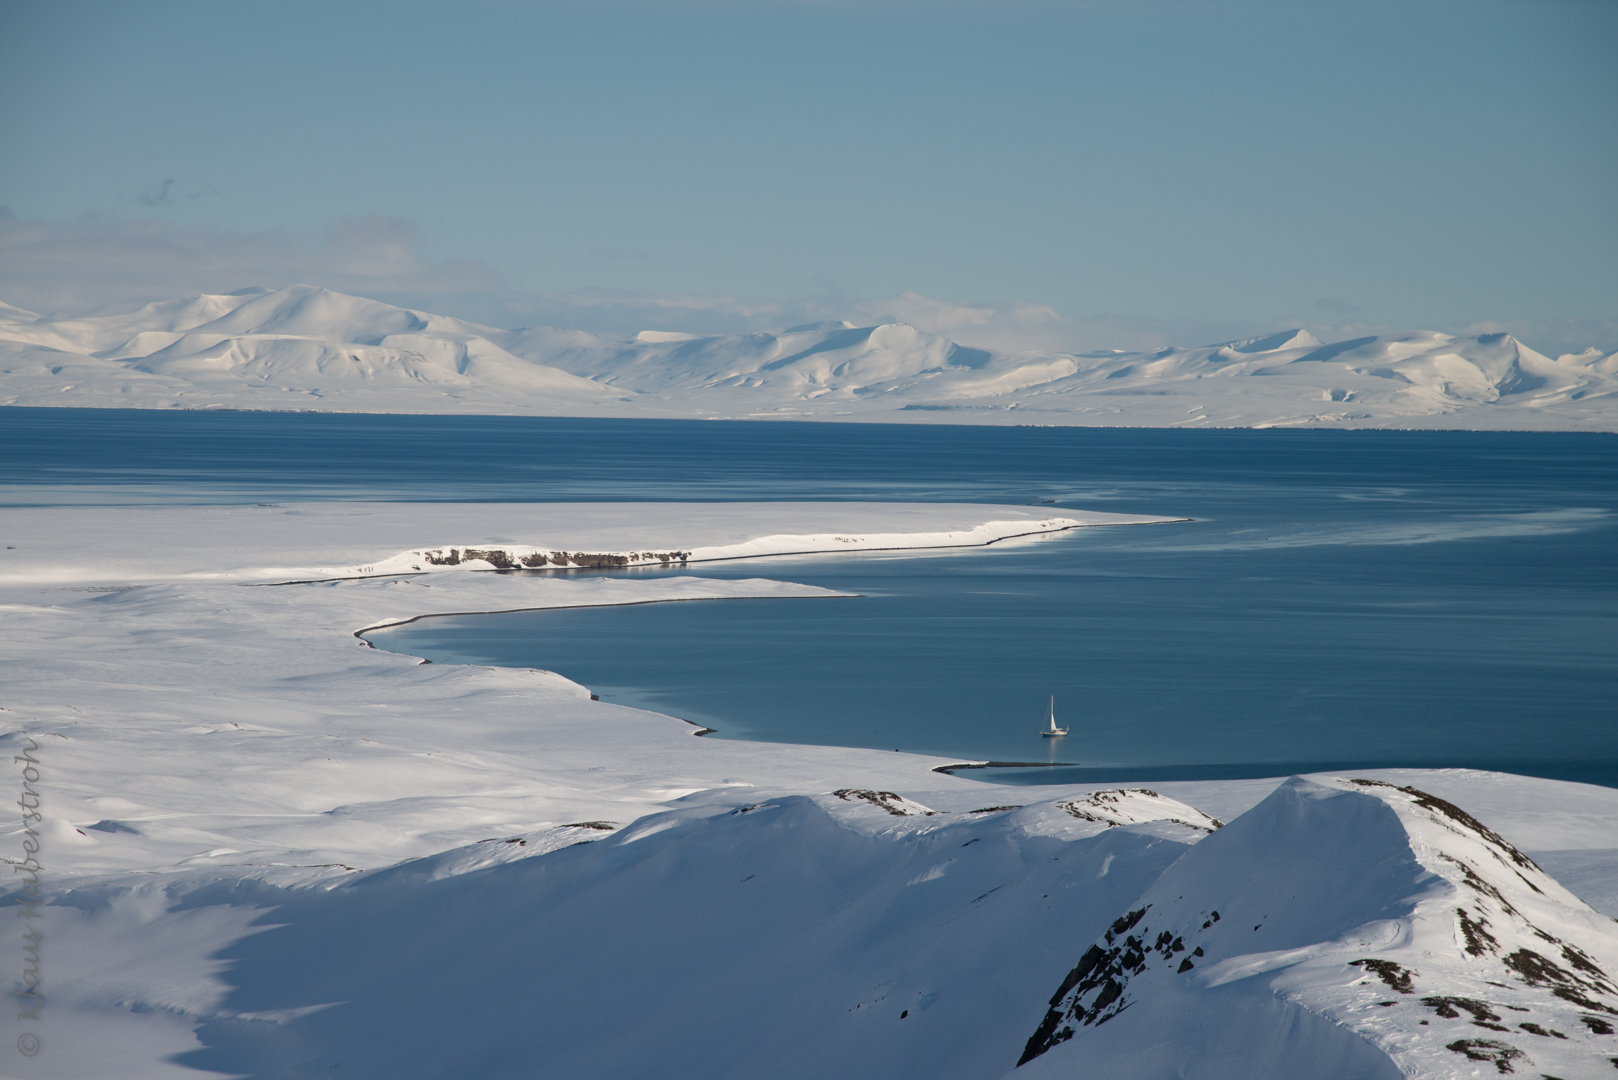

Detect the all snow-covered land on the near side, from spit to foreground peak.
[{"left": 0, "top": 504, "right": 1618, "bottom": 1080}]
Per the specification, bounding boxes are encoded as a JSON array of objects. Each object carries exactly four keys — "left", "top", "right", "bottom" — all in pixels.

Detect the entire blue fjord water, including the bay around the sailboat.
[{"left": 0, "top": 410, "right": 1618, "bottom": 785}]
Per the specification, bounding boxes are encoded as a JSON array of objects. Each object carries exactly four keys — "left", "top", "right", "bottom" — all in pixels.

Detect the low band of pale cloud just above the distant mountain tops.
[{"left": 0, "top": 212, "right": 1618, "bottom": 356}]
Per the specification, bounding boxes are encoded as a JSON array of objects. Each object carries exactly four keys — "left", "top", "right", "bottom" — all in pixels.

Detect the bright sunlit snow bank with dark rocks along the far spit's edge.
[{"left": 249, "top": 513, "right": 1191, "bottom": 585}]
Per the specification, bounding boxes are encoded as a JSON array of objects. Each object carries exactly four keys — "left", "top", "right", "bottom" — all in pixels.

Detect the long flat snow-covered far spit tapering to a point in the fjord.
[{"left": 0, "top": 502, "right": 1152, "bottom": 585}]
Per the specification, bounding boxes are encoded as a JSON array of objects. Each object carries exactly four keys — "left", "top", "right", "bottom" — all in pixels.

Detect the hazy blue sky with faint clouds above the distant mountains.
[{"left": 0, "top": 0, "right": 1618, "bottom": 351}]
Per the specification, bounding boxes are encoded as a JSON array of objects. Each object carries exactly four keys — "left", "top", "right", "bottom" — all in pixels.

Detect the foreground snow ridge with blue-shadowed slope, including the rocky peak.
[{"left": 152, "top": 779, "right": 1618, "bottom": 1080}]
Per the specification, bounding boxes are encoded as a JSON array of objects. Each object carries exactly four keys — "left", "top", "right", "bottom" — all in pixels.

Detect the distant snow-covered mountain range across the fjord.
[{"left": 0, "top": 285, "right": 1618, "bottom": 431}]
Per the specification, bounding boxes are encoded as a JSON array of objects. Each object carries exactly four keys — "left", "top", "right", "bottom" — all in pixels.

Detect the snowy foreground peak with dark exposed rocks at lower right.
[{"left": 1019, "top": 779, "right": 1618, "bottom": 1077}]
